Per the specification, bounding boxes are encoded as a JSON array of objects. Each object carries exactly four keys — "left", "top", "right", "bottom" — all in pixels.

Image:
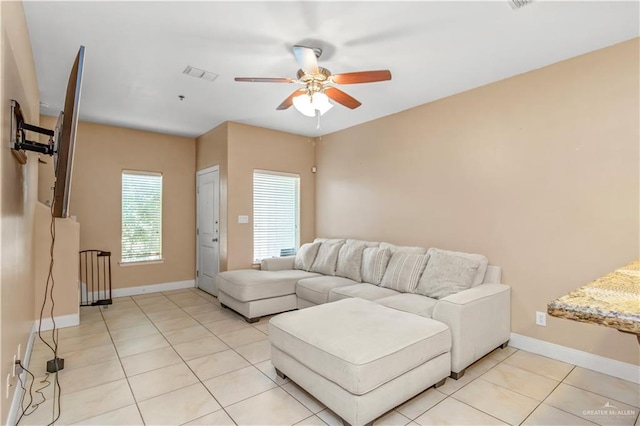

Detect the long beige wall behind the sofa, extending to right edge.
[{"left": 316, "top": 39, "right": 640, "bottom": 364}]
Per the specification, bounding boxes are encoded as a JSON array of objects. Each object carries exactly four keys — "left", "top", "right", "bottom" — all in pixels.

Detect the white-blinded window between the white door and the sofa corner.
[{"left": 253, "top": 170, "right": 300, "bottom": 262}]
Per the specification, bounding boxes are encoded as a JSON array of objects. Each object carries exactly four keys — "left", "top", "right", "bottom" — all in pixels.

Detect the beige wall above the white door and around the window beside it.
[{"left": 196, "top": 123, "right": 315, "bottom": 271}]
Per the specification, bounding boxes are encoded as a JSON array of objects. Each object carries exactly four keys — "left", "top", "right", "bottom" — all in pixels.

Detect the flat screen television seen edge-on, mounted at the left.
[{"left": 53, "top": 46, "right": 84, "bottom": 217}]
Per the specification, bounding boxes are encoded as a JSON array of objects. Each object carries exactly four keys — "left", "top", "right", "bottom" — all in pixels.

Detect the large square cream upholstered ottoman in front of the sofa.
[{"left": 269, "top": 299, "right": 451, "bottom": 426}]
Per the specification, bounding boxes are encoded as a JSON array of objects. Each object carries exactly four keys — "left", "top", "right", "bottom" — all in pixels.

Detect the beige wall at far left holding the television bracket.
[{"left": 0, "top": 1, "right": 40, "bottom": 423}]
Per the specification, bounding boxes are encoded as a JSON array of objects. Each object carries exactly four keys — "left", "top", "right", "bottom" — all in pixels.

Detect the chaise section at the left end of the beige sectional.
[{"left": 216, "top": 269, "right": 320, "bottom": 322}]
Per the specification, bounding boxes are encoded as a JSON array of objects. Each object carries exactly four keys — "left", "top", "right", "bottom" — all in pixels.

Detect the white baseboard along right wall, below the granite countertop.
[{"left": 509, "top": 333, "right": 640, "bottom": 383}]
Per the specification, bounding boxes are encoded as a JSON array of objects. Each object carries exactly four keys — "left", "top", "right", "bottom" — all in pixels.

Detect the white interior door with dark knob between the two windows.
[{"left": 196, "top": 166, "right": 220, "bottom": 296}]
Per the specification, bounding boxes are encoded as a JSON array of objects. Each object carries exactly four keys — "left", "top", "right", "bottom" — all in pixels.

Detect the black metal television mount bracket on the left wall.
[{"left": 9, "top": 99, "right": 55, "bottom": 164}]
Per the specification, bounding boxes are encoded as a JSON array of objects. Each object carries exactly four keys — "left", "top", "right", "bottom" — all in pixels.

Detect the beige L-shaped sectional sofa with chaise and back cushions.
[{"left": 216, "top": 238, "right": 510, "bottom": 378}]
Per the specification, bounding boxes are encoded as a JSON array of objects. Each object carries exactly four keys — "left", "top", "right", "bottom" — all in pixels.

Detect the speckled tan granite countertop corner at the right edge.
[{"left": 547, "top": 259, "right": 640, "bottom": 343}]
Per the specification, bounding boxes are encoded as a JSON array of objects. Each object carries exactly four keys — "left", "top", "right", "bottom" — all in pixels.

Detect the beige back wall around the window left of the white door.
[{"left": 42, "top": 116, "right": 195, "bottom": 288}]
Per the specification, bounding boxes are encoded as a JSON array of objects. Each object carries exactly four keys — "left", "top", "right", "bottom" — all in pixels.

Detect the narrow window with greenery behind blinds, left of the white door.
[{"left": 122, "top": 170, "right": 162, "bottom": 263}]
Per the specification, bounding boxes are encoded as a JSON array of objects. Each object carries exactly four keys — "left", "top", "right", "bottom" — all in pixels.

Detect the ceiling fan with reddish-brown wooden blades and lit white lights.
[{"left": 235, "top": 45, "right": 391, "bottom": 117}]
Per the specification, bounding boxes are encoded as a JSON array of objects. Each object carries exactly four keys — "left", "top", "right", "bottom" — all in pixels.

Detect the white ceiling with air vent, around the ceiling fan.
[{"left": 24, "top": 0, "right": 640, "bottom": 137}]
